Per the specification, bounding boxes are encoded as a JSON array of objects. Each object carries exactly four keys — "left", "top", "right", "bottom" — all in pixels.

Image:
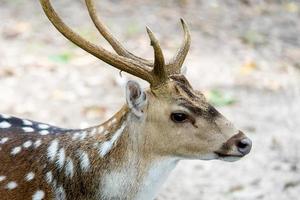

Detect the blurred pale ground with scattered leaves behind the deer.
[{"left": 0, "top": 0, "right": 300, "bottom": 200}]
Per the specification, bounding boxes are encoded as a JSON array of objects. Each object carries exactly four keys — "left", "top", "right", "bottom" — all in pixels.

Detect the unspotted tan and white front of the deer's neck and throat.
[{"left": 99, "top": 106, "right": 177, "bottom": 200}]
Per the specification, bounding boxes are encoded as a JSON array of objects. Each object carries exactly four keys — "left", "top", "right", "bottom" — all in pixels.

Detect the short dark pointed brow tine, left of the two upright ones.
[{"left": 146, "top": 27, "right": 167, "bottom": 83}]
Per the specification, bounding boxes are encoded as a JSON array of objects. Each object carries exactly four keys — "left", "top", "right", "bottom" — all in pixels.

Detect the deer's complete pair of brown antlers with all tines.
[{"left": 40, "top": 0, "right": 190, "bottom": 87}]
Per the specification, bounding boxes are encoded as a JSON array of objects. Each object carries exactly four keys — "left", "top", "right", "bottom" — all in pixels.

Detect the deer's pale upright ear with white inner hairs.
[{"left": 126, "top": 81, "right": 147, "bottom": 117}]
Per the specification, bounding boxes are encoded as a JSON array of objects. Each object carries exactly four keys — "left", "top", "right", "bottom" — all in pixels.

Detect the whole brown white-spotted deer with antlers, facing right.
[{"left": 0, "top": 0, "right": 252, "bottom": 200}]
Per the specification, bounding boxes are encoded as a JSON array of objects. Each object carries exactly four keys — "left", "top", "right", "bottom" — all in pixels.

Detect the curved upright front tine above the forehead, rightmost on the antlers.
[{"left": 167, "top": 18, "right": 191, "bottom": 74}]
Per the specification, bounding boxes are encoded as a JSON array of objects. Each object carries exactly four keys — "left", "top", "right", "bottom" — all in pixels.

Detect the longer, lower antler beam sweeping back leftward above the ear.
[{"left": 40, "top": 0, "right": 155, "bottom": 84}]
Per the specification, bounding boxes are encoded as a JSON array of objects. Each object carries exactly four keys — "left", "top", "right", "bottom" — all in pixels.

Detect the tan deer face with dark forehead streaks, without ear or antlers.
[{"left": 125, "top": 75, "right": 252, "bottom": 161}]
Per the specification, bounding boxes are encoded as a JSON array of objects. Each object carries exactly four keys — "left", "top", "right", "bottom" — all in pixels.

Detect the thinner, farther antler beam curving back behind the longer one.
[{"left": 85, "top": 0, "right": 153, "bottom": 66}]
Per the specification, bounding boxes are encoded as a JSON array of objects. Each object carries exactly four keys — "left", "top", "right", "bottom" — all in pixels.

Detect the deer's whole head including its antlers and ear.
[{"left": 41, "top": 0, "right": 251, "bottom": 161}]
